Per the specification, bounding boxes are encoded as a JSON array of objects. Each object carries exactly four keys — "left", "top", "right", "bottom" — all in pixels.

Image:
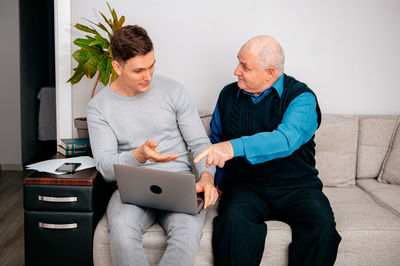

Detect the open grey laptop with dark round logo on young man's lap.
[{"left": 114, "top": 164, "right": 204, "bottom": 214}]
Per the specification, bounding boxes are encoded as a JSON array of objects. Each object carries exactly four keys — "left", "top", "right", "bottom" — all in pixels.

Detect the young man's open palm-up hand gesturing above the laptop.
[{"left": 133, "top": 140, "right": 179, "bottom": 163}]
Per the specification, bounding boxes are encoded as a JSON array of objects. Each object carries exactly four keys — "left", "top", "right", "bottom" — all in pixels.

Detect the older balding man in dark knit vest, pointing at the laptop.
[{"left": 195, "top": 36, "right": 341, "bottom": 265}]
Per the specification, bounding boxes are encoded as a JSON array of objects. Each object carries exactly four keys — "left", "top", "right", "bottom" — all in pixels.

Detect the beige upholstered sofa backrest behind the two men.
[{"left": 199, "top": 112, "right": 399, "bottom": 187}]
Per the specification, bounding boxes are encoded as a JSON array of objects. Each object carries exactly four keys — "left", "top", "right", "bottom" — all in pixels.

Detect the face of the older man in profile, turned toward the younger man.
[{"left": 234, "top": 49, "right": 269, "bottom": 95}]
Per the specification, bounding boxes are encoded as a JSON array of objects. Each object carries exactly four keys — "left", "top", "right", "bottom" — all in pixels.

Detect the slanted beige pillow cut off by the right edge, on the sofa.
[{"left": 378, "top": 118, "right": 400, "bottom": 185}]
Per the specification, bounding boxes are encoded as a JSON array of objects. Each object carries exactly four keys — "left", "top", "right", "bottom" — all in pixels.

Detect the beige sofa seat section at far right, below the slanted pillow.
[{"left": 357, "top": 179, "right": 400, "bottom": 216}]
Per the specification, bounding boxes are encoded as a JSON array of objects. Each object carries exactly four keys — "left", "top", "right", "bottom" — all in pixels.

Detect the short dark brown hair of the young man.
[{"left": 111, "top": 25, "right": 153, "bottom": 62}]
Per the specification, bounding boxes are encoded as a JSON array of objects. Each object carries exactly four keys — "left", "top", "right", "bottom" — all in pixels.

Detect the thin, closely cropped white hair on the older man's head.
[{"left": 242, "top": 35, "right": 285, "bottom": 76}]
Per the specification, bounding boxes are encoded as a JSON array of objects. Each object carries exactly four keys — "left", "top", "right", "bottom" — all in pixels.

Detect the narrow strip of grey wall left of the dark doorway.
[{"left": 0, "top": 0, "right": 21, "bottom": 167}]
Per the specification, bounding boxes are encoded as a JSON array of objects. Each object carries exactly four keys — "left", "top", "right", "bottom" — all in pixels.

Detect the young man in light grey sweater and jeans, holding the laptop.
[{"left": 87, "top": 26, "right": 218, "bottom": 265}]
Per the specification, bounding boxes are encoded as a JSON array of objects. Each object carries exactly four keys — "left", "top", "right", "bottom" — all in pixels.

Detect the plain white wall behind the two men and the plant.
[{"left": 65, "top": 0, "right": 400, "bottom": 135}]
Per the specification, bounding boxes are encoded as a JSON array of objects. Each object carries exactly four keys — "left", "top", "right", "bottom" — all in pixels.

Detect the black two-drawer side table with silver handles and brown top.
[{"left": 24, "top": 168, "right": 115, "bottom": 266}]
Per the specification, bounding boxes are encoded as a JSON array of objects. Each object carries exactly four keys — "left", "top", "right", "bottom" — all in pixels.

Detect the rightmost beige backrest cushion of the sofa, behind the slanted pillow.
[{"left": 357, "top": 115, "right": 397, "bottom": 179}]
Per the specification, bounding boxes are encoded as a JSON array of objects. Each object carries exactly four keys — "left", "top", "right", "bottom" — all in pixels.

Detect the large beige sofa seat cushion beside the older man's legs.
[{"left": 324, "top": 186, "right": 400, "bottom": 266}]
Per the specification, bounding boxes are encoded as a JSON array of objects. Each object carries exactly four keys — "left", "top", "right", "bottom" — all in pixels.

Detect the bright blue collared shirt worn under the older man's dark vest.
[{"left": 210, "top": 74, "right": 318, "bottom": 184}]
